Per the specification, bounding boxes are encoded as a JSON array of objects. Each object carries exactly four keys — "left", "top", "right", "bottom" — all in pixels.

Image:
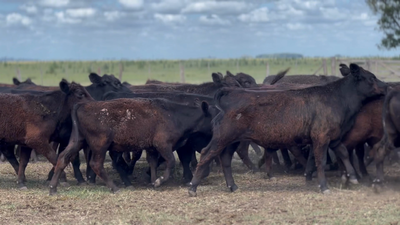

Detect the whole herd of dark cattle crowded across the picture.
[{"left": 0, "top": 64, "right": 400, "bottom": 196}]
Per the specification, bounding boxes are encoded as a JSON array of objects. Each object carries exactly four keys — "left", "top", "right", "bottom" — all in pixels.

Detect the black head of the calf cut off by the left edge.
[{"left": 60, "top": 79, "right": 93, "bottom": 107}]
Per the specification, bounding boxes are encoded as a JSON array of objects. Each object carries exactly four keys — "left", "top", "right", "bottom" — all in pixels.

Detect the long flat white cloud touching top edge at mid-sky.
[{"left": 182, "top": 1, "right": 250, "bottom": 14}]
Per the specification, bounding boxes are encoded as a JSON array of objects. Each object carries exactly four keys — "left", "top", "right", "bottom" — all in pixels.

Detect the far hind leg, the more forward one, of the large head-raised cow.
[{"left": 220, "top": 143, "right": 238, "bottom": 192}]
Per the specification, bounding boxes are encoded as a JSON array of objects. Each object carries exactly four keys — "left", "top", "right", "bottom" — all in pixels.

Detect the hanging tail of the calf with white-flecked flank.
[{"left": 60, "top": 104, "right": 81, "bottom": 163}]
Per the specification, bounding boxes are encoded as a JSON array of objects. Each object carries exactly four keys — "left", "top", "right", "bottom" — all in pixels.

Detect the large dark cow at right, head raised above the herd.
[{"left": 189, "top": 64, "right": 386, "bottom": 196}]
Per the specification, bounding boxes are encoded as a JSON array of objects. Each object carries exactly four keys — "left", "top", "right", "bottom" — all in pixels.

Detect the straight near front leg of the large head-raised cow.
[{"left": 313, "top": 139, "right": 330, "bottom": 194}]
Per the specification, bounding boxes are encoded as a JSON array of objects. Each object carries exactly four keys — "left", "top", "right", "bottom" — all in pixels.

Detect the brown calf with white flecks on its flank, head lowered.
[{"left": 50, "top": 99, "right": 215, "bottom": 194}]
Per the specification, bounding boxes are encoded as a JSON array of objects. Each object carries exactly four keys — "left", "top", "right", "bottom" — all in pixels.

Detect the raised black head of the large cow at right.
[{"left": 350, "top": 63, "right": 387, "bottom": 98}]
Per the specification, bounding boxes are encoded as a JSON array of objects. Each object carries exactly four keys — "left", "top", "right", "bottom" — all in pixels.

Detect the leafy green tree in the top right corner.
[{"left": 366, "top": 0, "right": 400, "bottom": 49}]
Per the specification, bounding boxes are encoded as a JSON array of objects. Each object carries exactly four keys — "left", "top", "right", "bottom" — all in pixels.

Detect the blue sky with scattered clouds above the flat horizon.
[{"left": 0, "top": 0, "right": 400, "bottom": 60}]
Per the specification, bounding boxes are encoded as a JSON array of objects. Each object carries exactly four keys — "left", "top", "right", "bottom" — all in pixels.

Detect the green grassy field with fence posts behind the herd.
[{"left": 0, "top": 58, "right": 400, "bottom": 85}]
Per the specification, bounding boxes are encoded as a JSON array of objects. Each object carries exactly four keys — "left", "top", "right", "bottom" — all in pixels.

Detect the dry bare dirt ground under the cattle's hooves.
[{"left": 0, "top": 151, "right": 400, "bottom": 225}]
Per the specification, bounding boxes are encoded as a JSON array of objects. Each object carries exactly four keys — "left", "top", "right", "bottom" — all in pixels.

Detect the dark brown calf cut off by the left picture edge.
[{"left": 0, "top": 80, "right": 92, "bottom": 187}]
